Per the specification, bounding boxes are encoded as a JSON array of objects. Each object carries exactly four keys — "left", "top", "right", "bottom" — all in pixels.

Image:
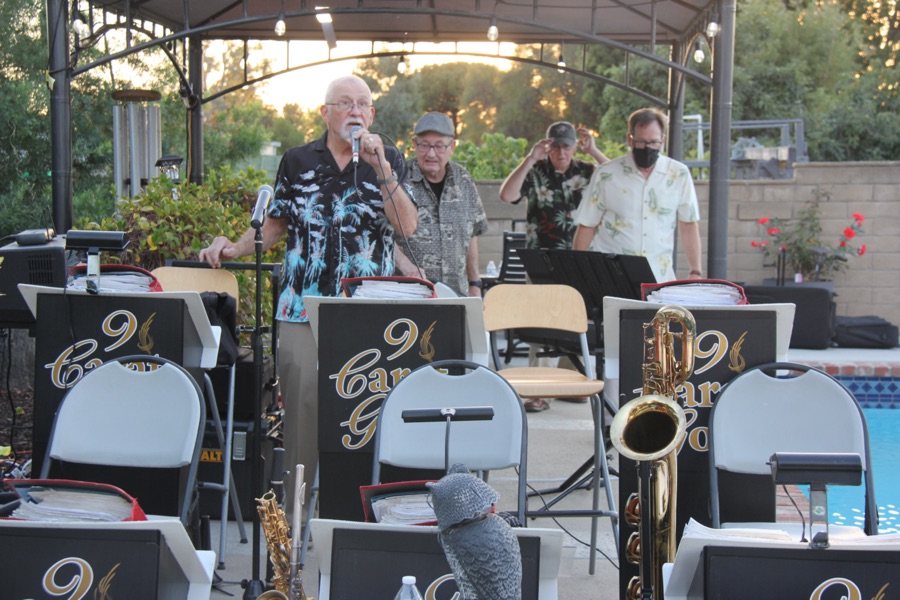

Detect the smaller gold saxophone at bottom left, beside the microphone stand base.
[{"left": 256, "top": 490, "right": 313, "bottom": 600}]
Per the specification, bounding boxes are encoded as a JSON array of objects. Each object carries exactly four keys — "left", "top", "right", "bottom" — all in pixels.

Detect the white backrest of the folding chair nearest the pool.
[{"left": 709, "top": 369, "right": 868, "bottom": 475}]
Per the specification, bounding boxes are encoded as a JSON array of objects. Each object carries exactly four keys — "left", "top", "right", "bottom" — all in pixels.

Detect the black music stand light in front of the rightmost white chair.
[{"left": 769, "top": 452, "right": 862, "bottom": 549}]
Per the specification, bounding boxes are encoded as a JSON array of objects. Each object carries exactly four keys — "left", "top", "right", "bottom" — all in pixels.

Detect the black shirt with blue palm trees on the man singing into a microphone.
[{"left": 268, "top": 133, "right": 413, "bottom": 323}]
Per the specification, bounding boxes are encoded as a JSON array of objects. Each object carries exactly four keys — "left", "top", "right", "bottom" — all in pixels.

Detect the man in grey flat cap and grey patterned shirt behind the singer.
[{"left": 394, "top": 112, "right": 488, "bottom": 297}]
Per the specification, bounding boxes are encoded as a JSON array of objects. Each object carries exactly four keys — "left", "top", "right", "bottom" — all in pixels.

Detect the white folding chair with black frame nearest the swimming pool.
[{"left": 709, "top": 363, "right": 878, "bottom": 535}]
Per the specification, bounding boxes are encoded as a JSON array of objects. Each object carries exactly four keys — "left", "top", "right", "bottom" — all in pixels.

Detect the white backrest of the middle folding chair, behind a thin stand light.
[{"left": 375, "top": 361, "right": 527, "bottom": 470}]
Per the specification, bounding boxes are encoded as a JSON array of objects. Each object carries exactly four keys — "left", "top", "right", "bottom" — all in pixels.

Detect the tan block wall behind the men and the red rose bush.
[{"left": 478, "top": 162, "right": 900, "bottom": 324}]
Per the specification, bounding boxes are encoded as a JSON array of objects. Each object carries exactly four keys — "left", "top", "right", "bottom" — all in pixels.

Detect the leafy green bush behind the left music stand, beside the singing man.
[{"left": 76, "top": 168, "right": 281, "bottom": 322}]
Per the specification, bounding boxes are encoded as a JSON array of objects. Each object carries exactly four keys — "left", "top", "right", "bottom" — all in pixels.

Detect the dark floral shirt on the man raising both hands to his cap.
[{"left": 516, "top": 158, "right": 596, "bottom": 250}]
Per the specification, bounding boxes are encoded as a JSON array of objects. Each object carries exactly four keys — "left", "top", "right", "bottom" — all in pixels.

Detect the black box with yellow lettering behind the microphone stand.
[{"left": 197, "top": 421, "right": 274, "bottom": 521}]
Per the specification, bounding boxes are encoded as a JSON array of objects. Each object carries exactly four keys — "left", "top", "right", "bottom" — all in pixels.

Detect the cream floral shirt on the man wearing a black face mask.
[{"left": 575, "top": 152, "right": 700, "bottom": 282}]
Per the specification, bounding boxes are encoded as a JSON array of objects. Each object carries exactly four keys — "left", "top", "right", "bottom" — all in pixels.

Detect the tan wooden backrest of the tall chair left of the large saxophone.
[{"left": 484, "top": 284, "right": 588, "bottom": 333}]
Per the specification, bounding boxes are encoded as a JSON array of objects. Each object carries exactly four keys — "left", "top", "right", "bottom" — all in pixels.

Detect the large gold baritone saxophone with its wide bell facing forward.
[{"left": 610, "top": 305, "right": 697, "bottom": 600}]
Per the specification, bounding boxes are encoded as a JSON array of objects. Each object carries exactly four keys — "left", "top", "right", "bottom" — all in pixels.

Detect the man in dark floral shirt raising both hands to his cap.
[{"left": 500, "top": 121, "right": 609, "bottom": 250}]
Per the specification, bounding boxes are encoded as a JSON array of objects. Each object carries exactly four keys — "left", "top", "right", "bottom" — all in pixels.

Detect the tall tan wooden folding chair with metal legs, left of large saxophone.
[{"left": 484, "top": 284, "right": 618, "bottom": 573}]
